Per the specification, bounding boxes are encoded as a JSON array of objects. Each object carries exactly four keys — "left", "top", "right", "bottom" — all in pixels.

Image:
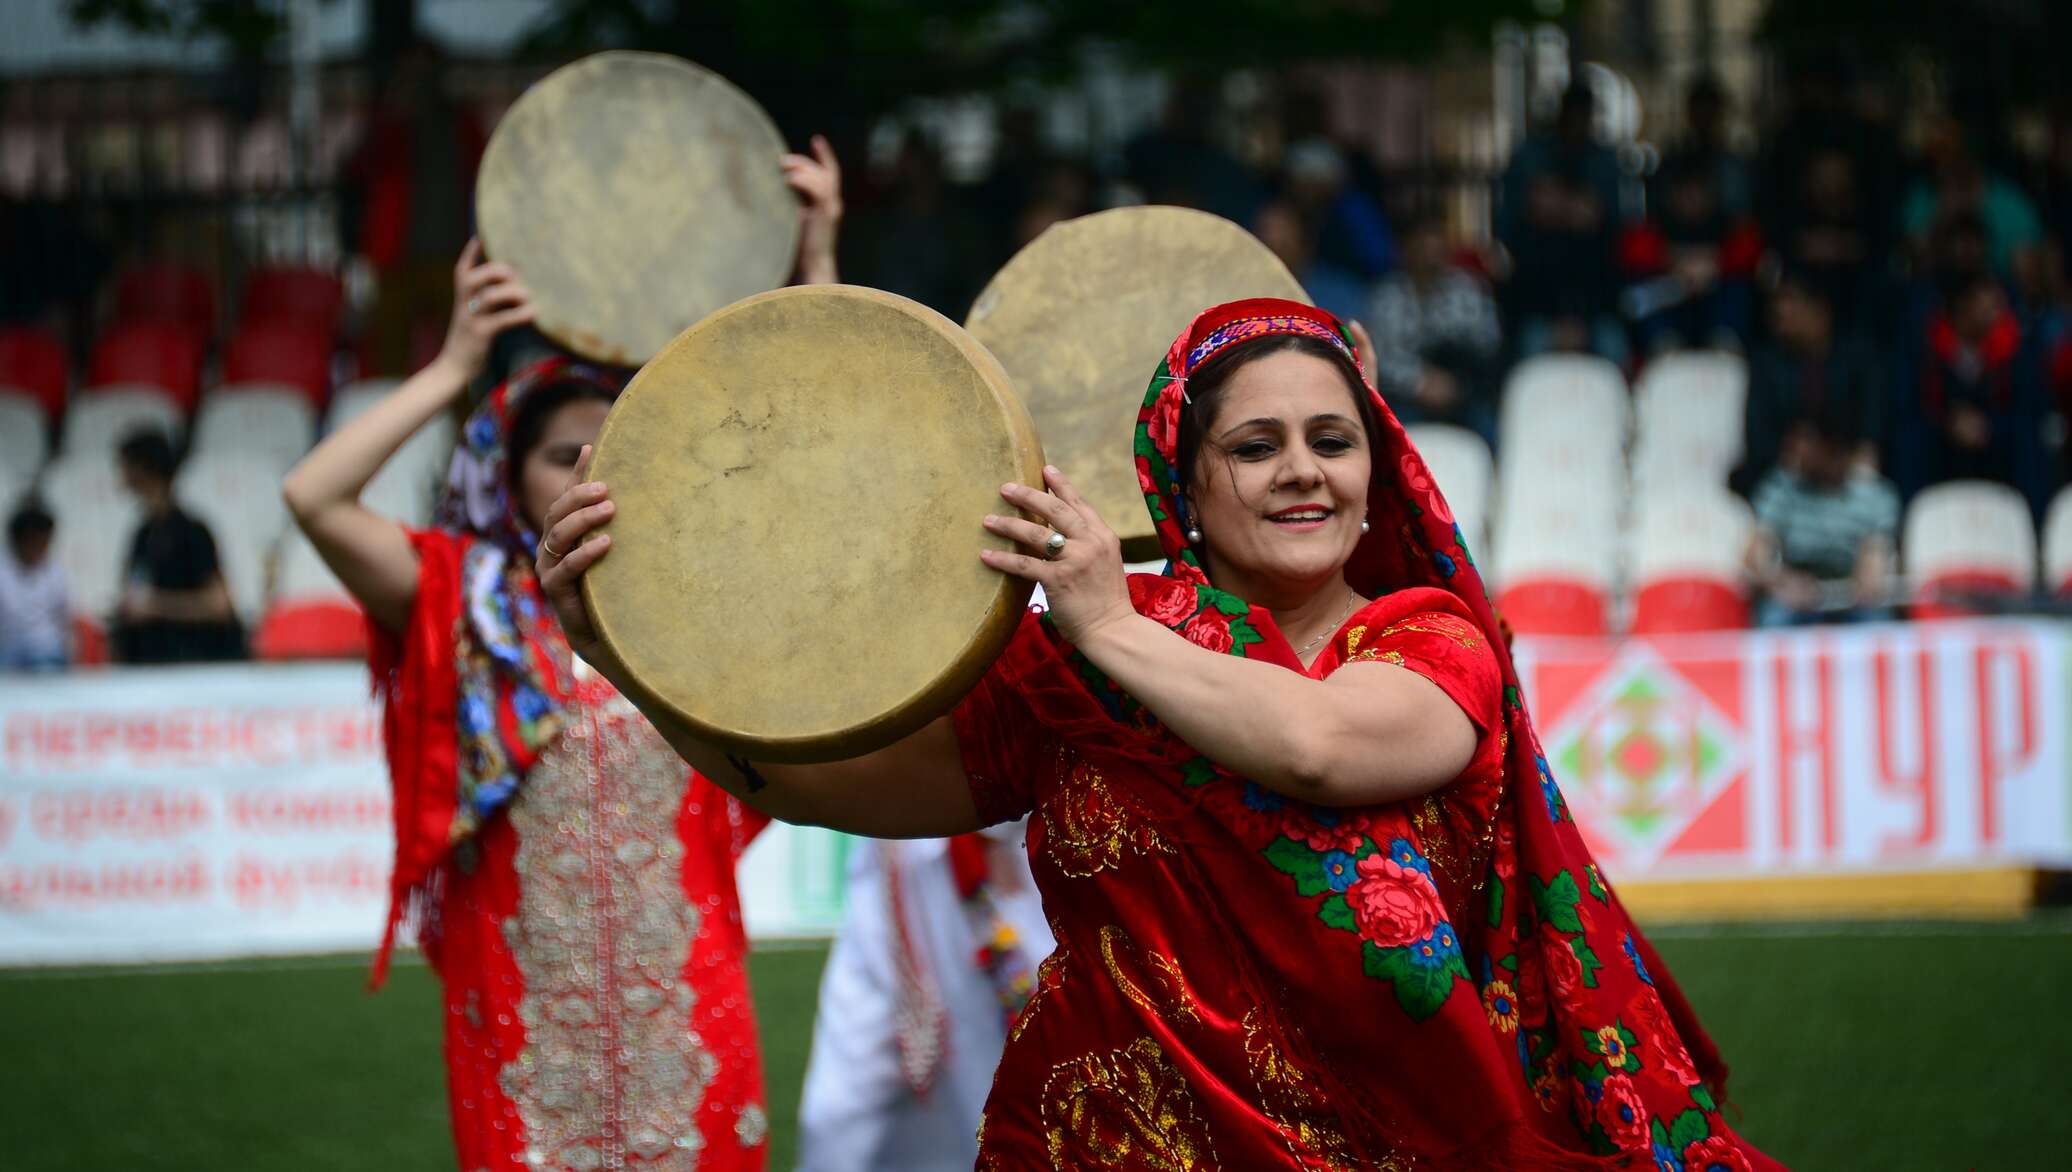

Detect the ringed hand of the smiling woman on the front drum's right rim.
[{"left": 978, "top": 468, "right": 1138, "bottom": 646}]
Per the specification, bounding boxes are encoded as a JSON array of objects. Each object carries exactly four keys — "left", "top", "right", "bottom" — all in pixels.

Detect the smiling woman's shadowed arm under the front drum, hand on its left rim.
[{"left": 535, "top": 447, "right": 980, "bottom": 839}]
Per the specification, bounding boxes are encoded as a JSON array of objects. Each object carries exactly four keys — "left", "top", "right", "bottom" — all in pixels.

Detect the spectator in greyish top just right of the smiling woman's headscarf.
[{"left": 1368, "top": 217, "right": 1504, "bottom": 447}]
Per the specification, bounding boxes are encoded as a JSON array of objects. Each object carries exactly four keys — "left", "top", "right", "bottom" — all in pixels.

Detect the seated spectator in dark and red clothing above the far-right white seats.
[{"left": 1892, "top": 275, "right": 2049, "bottom": 518}]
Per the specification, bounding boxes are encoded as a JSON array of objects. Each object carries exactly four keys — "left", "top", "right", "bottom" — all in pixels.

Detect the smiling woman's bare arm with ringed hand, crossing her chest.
[{"left": 980, "top": 468, "right": 1479, "bottom": 805}]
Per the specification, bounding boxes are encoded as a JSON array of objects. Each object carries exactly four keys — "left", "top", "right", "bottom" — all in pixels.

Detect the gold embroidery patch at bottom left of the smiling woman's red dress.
[{"left": 1042, "top": 1037, "right": 1218, "bottom": 1172}]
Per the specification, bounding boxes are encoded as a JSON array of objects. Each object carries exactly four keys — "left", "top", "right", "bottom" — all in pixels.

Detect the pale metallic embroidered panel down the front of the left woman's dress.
[{"left": 499, "top": 708, "right": 719, "bottom": 1172}]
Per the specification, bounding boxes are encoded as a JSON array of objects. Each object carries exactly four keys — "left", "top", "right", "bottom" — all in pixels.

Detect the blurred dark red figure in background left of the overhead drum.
[{"left": 344, "top": 39, "right": 489, "bottom": 375}]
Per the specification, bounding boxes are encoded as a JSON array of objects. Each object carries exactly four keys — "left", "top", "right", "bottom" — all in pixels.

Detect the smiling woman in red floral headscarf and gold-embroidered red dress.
[{"left": 541, "top": 300, "right": 1774, "bottom": 1172}]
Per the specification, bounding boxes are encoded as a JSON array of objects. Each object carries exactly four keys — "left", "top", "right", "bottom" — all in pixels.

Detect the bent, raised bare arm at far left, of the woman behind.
[{"left": 280, "top": 240, "right": 533, "bottom": 632}]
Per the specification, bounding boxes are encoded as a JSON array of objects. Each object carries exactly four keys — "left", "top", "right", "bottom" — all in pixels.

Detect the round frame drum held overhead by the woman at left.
[{"left": 474, "top": 52, "right": 798, "bottom": 367}]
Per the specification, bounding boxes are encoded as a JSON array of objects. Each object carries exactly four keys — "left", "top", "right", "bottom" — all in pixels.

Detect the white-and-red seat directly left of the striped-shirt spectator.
[{"left": 1627, "top": 485, "right": 1755, "bottom": 636}]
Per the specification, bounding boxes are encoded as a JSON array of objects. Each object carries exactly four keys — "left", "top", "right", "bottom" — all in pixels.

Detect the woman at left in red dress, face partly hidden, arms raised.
[{"left": 282, "top": 143, "right": 839, "bottom": 1172}]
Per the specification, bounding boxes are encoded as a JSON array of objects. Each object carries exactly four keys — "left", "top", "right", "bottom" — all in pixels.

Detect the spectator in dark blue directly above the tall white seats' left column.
[{"left": 1496, "top": 85, "right": 1627, "bottom": 364}]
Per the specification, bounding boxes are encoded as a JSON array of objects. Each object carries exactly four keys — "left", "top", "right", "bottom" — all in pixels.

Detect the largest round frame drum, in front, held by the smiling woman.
[{"left": 582, "top": 286, "right": 1042, "bottom": 768}]
